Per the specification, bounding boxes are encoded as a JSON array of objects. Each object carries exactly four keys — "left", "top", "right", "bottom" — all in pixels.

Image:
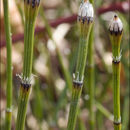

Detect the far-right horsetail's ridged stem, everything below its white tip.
[{"left": 110, "top": 29, "right": 122, "bottom": 130}]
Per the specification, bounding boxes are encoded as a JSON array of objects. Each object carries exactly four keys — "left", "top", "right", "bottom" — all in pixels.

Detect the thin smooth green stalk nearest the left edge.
[{"left": 3, "top": 0, "right": 12, "bottom": 130}]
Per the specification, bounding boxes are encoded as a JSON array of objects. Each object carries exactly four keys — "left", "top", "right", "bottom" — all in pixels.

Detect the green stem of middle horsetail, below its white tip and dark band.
[{"left": 67, "top": 23, "right": 91, "bottom": 130}]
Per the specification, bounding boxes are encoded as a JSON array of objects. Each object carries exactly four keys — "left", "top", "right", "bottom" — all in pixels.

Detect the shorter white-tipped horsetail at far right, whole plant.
[{"left": 109, "top": 15, "right": 123, "bottom": 130}]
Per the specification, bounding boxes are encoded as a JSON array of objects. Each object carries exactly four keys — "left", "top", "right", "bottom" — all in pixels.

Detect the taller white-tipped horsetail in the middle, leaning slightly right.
[{"left": 67, "top": 0, "right": 94, "bottom": 130}]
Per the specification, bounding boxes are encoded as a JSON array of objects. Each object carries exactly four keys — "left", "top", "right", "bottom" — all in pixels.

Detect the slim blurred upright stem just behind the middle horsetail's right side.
[{"left": 86, "top": 28, "right": 94, "bottom": 130}]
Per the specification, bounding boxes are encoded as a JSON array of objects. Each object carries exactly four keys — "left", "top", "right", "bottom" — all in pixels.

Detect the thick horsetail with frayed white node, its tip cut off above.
[{"left": 16, "top": 0, "right": 40, "bottom": 130}]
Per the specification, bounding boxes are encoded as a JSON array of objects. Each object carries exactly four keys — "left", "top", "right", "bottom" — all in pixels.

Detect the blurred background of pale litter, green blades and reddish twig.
[{"left": 0, "top": 0, "right": 130, "bottom": 130}]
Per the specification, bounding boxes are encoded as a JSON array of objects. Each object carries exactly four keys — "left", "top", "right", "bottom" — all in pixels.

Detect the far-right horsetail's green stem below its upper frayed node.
[{"left": 112, "top": 62, "right": 121, "bottom": 130}]
